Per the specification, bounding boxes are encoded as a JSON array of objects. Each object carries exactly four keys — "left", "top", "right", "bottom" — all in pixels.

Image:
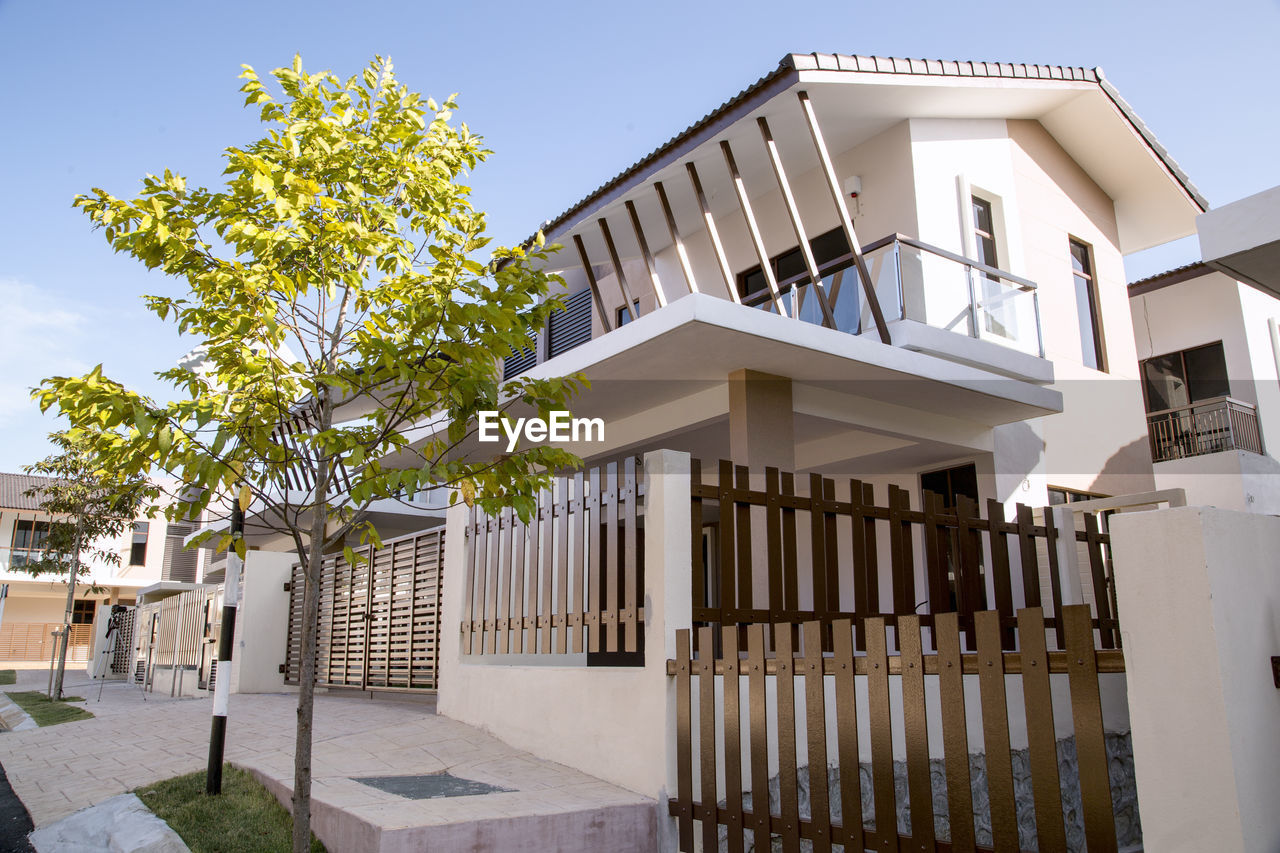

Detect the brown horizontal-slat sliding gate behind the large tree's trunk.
[{"left": 284, "top": 529, "right": 444, "bottom": 690}]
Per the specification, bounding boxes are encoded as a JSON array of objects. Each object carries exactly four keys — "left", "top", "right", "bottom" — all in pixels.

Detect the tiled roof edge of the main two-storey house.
[{"left": 527, "top": 53, "right": 1210, "bottom": 243}]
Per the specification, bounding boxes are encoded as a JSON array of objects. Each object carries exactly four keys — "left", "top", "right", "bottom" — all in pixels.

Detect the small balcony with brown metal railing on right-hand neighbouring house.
[{"left": 1147, "top": 397, "right": 1263, "bottom": 462}]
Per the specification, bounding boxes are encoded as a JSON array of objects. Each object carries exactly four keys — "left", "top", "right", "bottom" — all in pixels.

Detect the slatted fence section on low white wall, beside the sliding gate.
[{"left": 461, "top": 456, "right": 645, "bottom": 654}]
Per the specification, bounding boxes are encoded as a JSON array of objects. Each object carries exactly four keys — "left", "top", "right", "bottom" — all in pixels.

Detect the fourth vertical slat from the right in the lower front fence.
[{"left": 933, "top": 612, "right": 977, "bottom": 853}]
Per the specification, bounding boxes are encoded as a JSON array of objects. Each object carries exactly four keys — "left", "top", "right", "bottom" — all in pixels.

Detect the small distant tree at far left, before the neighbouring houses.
[{"left": 15, "top": 429, "right": 157, "bottom": 699}]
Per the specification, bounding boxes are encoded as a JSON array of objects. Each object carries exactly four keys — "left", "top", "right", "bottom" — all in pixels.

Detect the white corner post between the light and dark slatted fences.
[{"left": 644, "top": 451, "right": 694, "bottom": 850}]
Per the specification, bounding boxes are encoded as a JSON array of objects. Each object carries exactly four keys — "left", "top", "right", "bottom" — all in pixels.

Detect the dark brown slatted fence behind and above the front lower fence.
[{"left": 691, "top": 460, "right": 1120, "bottom": 652}]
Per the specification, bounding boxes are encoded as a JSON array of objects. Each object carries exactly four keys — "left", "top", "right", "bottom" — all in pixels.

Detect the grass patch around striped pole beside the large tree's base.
[{"left": 136, "top": 765, "right": 325, "bottom": 853}]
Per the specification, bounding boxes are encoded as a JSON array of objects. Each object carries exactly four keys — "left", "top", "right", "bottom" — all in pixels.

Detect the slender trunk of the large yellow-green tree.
[{"left": 293, "top": 394, "right": 333, "bottom": 853}]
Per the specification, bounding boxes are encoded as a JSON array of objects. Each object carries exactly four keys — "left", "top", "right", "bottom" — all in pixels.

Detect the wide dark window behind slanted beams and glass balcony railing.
[{"left": 737, "top": 228, "right": 861, "bottom": 334}]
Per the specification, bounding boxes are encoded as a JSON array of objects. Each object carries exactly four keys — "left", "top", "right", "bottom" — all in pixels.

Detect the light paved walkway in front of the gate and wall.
[{"left": 0, "top": 671, "right": 657, "bottom": 853}]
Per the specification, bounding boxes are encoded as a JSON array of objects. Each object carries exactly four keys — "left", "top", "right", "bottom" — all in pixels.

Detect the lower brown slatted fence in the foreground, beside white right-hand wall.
[{"left": 667, "top": 606, "right": 1124, "bottom": 853}]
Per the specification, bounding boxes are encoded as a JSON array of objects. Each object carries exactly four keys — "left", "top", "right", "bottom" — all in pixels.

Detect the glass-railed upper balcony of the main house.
[{"left": 504, "top": 234, "right": 1052, "bottom": 384}]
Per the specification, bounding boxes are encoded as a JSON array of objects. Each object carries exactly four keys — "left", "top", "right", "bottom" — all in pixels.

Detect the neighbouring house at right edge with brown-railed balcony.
[{"left": 1129, "top": 187, "right": 1280, "bottom": 514}]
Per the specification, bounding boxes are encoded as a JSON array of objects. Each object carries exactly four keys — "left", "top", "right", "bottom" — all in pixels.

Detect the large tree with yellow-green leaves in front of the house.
[{"left": 36, "top": 58, "right": 582, "bottom": 853}]
